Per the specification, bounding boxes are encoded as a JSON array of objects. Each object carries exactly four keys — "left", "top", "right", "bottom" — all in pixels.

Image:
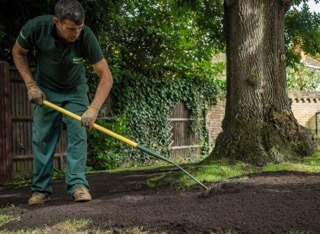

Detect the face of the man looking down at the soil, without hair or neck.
[{"left": 54, "top": 18, "right": 84, "bottom": 42}]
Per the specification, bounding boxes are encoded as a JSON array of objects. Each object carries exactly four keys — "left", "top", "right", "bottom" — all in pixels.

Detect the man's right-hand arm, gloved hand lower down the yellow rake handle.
[{"left": 81, "top": 59, "right": 113, "bottom": 130}]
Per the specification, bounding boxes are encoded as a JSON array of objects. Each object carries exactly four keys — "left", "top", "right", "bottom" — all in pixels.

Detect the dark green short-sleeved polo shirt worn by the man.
[{"left": 17, "top": 15, "right": 103, "bottom": 90}]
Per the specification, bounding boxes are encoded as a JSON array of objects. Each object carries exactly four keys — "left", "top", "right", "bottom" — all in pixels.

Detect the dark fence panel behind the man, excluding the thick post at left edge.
[{"left": 10, "top": 68, "right": 67, "bottom": 177}]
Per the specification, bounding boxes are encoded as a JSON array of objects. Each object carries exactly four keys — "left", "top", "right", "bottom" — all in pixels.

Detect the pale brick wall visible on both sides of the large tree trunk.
[{"left": 206, "top": 91, "right": 320, "bottom": 149}]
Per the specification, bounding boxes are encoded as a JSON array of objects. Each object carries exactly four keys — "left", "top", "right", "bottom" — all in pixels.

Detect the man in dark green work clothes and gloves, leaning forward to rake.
[{"left": 12, "top": 0, "right": 113, "bottom": 205}]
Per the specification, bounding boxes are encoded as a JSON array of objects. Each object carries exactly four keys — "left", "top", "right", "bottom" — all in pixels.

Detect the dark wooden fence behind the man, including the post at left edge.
[{"left": 0, "top": 62, "right": 66, "bottom": 184}]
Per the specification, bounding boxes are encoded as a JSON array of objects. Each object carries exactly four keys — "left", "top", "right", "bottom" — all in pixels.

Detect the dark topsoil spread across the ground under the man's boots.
[{"left": 0, "top": 167, "right": 320, "bottom": 233}]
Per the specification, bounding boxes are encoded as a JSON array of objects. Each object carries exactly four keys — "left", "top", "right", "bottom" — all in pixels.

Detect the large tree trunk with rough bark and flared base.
[{"left": 204, "top": 0, "right": 315, "bottom": 165}]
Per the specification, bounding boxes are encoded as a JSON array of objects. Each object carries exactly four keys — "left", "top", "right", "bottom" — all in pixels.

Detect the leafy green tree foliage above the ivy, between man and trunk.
[{"left": 100, "top": 0, "right": 223, "bottom": 79}]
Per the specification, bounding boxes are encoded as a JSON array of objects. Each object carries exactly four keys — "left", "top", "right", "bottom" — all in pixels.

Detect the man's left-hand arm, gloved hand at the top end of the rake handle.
[{"left": 12, "top": 41, "right": 45, "bottom": 105}]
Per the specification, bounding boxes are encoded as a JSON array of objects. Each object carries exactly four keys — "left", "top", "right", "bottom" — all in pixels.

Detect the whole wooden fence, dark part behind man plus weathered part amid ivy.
[{"left": 0, "top": 62, "right": 201, "bottom": 184}]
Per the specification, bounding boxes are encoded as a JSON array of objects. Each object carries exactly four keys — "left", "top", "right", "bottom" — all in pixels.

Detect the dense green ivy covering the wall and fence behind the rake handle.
[{"left": 89, "top": 75, "right": 224, "bottom": 167}]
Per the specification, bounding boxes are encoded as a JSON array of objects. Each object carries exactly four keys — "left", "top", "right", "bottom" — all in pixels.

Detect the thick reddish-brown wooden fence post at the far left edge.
[{"left": 0, "top": 61, "right": 12, "bottom": 184}]
